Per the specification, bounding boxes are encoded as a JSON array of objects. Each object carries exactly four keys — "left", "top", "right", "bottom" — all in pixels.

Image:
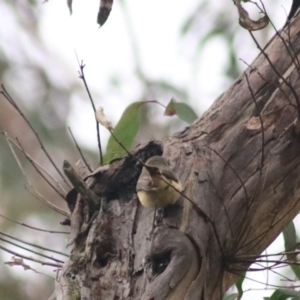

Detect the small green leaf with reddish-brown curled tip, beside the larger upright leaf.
[{"left": 164, "top": 98, "right": 198, "bottom": 124}]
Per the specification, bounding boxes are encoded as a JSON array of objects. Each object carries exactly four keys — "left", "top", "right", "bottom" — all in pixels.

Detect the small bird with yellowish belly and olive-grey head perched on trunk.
[{"left": 136, "top": 156, "right": 182, "bottom": 208}]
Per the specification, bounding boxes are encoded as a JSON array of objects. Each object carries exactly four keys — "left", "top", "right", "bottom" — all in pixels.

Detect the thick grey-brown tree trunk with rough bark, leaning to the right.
[{"left": 56, "top": 17, "right": 300, "bottom": 300}]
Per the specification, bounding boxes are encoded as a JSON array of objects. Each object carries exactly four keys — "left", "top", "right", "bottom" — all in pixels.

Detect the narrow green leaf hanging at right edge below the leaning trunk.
[{"left": 282, "top": 221, "right": 300, "bottom": 280}]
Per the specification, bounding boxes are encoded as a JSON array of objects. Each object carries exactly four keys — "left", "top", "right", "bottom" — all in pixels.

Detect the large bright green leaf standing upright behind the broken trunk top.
[{"left": 104, "top": 102, "right": 145, "bottom": 162}]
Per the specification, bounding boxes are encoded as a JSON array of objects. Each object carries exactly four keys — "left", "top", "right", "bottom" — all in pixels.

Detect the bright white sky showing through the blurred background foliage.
[{"left": 41, "top": 0, "right": 289, "bottom": 149}]
